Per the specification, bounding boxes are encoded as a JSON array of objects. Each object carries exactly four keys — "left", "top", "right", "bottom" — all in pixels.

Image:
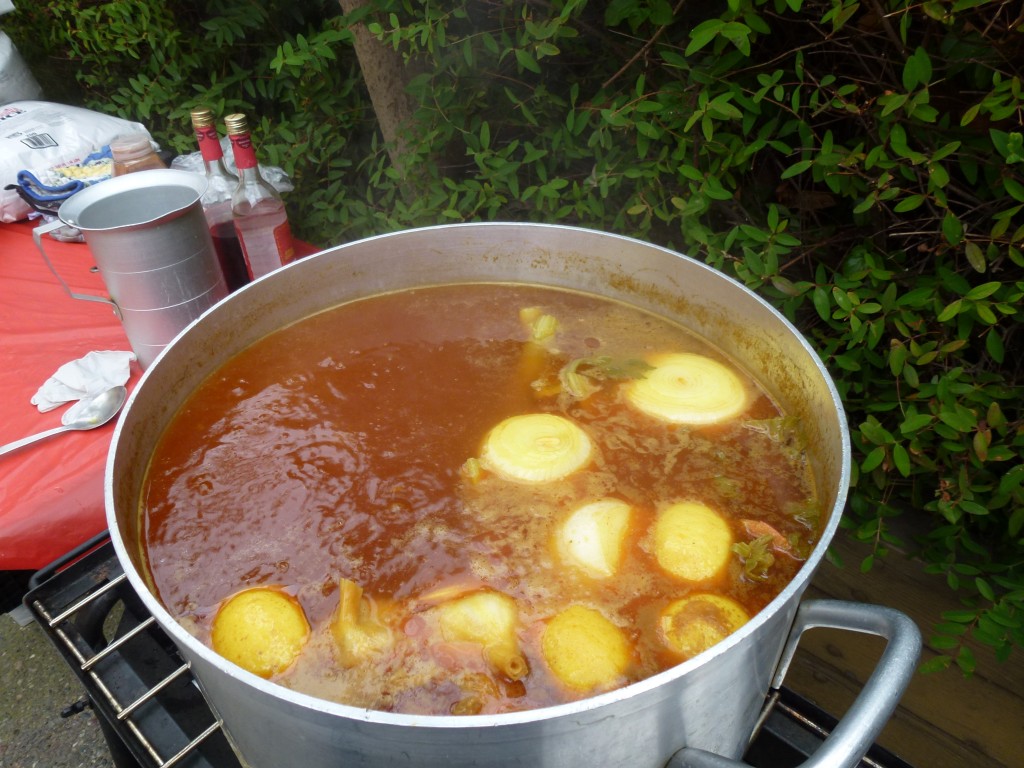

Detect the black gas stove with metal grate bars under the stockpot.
[{"left": 25, "top": 532, "right": 911, "bottom": 768}]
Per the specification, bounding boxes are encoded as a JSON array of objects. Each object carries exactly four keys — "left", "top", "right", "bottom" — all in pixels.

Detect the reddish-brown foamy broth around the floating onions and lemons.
[{"left": 140, "top": 285, "right": 818, "bottom": 714}]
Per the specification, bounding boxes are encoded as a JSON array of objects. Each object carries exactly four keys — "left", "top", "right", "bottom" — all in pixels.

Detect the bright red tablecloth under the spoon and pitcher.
[{"left": 0, "top": 221, "right": 141, "bottom": 569}]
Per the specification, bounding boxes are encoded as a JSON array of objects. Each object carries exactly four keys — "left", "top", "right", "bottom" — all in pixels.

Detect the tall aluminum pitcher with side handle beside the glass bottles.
[{"left": 33, "top": 170, "right": 228, "bottom": 369}]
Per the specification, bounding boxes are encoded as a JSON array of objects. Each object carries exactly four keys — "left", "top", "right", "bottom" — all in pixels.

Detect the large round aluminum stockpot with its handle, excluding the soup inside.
[{"left": 105, "top": 223, "right": 921, "bottom": 768}]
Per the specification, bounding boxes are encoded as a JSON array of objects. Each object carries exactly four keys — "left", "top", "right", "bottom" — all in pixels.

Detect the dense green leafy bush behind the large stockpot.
[{"left": 11, "top": 0, "right": 1024, "bottom": 673}]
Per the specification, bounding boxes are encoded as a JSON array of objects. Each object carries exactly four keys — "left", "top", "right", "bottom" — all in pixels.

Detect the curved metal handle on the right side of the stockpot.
[{"left": 666, "top": 600, "right": 921, "bottom": 768}]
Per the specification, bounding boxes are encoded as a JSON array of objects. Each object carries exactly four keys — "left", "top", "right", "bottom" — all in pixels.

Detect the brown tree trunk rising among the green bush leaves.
[{"left": 338, "top": 0, "right": 413, "bottom": 178}]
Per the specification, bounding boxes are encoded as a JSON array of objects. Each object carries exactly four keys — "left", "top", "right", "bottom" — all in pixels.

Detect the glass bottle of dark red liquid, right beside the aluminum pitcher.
[{"left": 191, "top": 106, "right": 249, "bottom": 291}]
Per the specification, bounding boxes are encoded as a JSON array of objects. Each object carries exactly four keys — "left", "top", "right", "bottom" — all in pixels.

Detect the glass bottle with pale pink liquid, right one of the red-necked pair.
[{"left": 224, "top": 114, "right": 295, "bottom": 280}]
